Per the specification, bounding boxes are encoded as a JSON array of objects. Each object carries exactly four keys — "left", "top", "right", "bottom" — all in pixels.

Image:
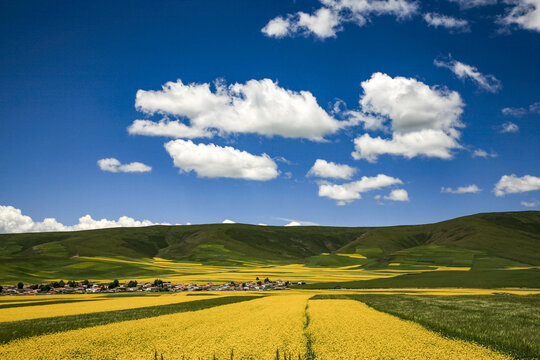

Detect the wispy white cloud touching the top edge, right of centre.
[{"left": 261, "top": 0, "right": 418, "bottom": 39}]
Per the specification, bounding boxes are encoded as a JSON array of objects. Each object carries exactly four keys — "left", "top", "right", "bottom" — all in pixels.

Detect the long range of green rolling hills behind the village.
[{"left": 0, "top": 211, "right": 540, "bottom": 283}]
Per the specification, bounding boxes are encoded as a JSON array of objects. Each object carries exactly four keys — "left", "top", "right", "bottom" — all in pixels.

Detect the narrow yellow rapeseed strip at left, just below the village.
[{"left": 0, "top": 293, "right": 224, "bottom": 323}]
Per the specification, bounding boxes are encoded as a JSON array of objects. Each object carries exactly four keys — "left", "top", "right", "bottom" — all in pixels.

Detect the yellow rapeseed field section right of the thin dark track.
[{"left": 308, "top": 300, "right": 510, "bottom": 360}]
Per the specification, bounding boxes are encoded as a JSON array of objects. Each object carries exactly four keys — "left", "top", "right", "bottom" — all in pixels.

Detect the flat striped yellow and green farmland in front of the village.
[{"left": 0, "top": 289, "right": 540, "bottom": 359}]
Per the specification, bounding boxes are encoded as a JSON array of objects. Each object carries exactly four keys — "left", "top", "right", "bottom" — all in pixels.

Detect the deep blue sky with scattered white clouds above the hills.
[{"left": 0, "top": 0, "right": 540, "bottom": 232}]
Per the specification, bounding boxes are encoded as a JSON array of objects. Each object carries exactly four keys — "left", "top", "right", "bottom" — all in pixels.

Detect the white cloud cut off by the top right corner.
[{"left": 499, "top": 0, "right": 540, "bottom": 31}]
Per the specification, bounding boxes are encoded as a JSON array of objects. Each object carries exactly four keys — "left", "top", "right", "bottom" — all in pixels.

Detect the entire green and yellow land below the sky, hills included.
[{"left": 0, "top": 212, "right": 540, "bottom": 360}]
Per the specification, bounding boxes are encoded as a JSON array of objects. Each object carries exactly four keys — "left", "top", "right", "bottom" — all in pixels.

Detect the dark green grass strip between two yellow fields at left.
[{"left": 0, "top": 296, "right": 261, "bottom": 344}]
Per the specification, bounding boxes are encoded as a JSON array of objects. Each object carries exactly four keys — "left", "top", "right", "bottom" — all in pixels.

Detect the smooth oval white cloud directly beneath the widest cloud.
[{"left": 165, "top": 140, "right": 279, "bottom": 181}]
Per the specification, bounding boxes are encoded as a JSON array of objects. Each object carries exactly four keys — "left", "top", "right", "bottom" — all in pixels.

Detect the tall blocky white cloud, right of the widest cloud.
[{"left": 352, "top": 73, "right": 464, "bottom": 162}]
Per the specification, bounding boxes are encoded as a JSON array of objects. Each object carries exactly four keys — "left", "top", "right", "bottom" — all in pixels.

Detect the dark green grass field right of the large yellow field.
[{"left": 312, "top": 294, "right": 540, "bottom": 359}]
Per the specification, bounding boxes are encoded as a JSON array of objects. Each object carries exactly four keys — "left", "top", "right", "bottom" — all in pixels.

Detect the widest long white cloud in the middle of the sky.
[{"left": 128, "top": 79, "right": 350, "bottom": 141}]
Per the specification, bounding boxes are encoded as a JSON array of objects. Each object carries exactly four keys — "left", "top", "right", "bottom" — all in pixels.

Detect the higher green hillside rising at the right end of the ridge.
[{"left": 340, "top": 211, "right": 540, "bottom": 265}]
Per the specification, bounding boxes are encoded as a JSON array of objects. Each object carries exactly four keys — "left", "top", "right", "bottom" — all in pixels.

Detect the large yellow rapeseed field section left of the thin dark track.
[{"left": 0, "top": 294, "right": 310, "bottom": 360}]
